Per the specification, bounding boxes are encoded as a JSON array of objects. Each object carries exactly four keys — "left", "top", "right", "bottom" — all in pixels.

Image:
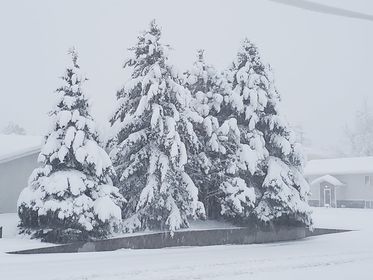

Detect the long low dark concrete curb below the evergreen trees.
[{"left": 8, "top": 226, "right": 345, "bottom": 254}]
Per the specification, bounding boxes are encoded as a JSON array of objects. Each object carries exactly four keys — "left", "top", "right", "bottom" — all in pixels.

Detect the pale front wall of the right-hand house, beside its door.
[{"left": 307, "top": 174, "right": 373, "bottom": 208}]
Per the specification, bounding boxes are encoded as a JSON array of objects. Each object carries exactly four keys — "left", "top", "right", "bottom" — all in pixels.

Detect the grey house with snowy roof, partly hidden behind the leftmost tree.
[{"left": 0, "top": 134, "right": 42, "bottom": 214}]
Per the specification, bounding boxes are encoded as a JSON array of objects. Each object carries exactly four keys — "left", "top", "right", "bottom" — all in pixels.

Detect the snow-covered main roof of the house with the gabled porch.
[{"left": 304, "top": 157, "right": 373, "bottom": 176}]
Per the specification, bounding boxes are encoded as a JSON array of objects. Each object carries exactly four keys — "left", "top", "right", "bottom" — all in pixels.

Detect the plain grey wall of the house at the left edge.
[{"left": 0, "top": 153, "right": 38, "bottom": 213}]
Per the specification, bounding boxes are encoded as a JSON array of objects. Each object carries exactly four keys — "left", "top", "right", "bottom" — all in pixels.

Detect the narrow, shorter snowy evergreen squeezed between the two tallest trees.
[{"left": 185, "top": 50, "right": 229, "bottom": 218}]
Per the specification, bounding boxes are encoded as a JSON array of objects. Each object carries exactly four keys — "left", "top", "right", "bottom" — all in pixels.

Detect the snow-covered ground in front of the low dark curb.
[{"left": 0, "top": 208, "right": 373, "bottom": 280}]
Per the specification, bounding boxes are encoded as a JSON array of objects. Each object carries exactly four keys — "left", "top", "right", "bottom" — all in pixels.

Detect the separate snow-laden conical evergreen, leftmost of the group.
[{"left": 18, "top": 49, "right": 123, "bottom": 243}]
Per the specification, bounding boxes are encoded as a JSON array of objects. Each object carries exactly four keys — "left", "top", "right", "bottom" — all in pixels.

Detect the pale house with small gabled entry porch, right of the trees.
[{"left": 304, "top": 157, "right": 373, "bottom": 208}]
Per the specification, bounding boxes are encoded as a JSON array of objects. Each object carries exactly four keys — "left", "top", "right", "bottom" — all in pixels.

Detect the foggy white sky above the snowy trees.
[{"left": 0, "top": 0, "right": 373, "bottom": 151}]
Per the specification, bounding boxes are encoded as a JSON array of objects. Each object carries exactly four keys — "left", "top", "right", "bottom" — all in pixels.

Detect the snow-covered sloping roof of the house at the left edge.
[{"left": 0, "top": 134, "right": 43, "bottom": 163}]
